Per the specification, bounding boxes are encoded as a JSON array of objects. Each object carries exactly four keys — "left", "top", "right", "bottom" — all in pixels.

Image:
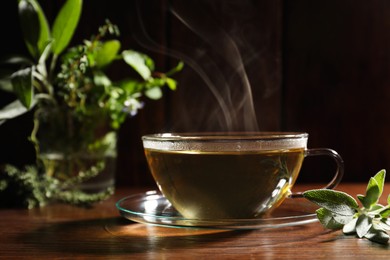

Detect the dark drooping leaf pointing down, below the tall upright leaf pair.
[{"left": 11, "top": 68, "right": 34, "bottom": 109}]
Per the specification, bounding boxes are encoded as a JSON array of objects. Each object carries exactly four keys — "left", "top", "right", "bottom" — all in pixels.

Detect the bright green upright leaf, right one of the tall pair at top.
[{"left": 52, "top": 0, "right": 83, "bottom": 55}]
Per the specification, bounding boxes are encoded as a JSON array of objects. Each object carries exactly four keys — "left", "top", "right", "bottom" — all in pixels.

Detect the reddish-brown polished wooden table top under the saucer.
[{"left": 0, "top": 184, "right": 390, "bottom": 259}]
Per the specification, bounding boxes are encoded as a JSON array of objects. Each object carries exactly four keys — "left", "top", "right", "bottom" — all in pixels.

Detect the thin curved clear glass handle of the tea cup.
[{"left": 290, "top": 148, "right": 344, "bottom": 198}]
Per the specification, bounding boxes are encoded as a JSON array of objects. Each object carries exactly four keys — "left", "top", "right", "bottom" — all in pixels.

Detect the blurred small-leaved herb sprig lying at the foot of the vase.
[{"left": 0, "top": 163, "right": 113, "bottom": 209}]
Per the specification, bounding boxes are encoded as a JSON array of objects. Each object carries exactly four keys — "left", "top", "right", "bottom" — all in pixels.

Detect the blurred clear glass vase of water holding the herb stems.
[{"left": 32, "top": 108, "right": 117, "bottom": 193}]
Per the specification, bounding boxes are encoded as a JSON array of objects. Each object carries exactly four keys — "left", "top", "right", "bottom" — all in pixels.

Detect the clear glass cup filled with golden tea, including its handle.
[{"left": 142, "top": 133, "right": 343, "bottom": 219}]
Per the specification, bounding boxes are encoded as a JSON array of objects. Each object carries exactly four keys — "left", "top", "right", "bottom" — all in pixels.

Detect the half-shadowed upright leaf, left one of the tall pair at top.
[{"left": 18, "top": 0, "right": 50, "bottom": 58}]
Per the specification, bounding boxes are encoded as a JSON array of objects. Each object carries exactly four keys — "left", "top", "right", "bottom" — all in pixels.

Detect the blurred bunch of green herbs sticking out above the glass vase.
[{"left": 0, "top": 0, "right": 183, "bottom": 205}]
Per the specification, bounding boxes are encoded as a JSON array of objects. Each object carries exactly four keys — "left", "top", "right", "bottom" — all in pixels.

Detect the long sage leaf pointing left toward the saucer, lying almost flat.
[{"left": 303, "top": 189, "right": 359, "bottom": 216}]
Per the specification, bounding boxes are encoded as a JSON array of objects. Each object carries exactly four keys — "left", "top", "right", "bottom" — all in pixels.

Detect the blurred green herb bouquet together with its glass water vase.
[{"left": 0, "top": 0, "right": 183, "bottom": 208}]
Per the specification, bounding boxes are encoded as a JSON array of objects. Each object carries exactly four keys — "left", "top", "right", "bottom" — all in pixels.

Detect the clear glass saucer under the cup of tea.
[{"left": 116, "top": 191, "right": 318, "bottom": 229}]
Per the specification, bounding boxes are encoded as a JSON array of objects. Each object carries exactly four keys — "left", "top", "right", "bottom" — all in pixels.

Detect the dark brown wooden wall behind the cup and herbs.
[{"left": 0, "top": 0, "right": 390, "bottom": 186}]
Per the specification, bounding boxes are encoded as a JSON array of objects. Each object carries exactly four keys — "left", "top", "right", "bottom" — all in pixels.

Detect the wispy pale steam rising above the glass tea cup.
[{"left": 136, "top": 1, "right": 276, "bottom": 131}]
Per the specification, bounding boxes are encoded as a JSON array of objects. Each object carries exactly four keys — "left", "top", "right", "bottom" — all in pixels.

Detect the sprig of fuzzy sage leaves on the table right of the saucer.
[{"left": 303, "top": 170, "right": 390, "bottom": 244}]
